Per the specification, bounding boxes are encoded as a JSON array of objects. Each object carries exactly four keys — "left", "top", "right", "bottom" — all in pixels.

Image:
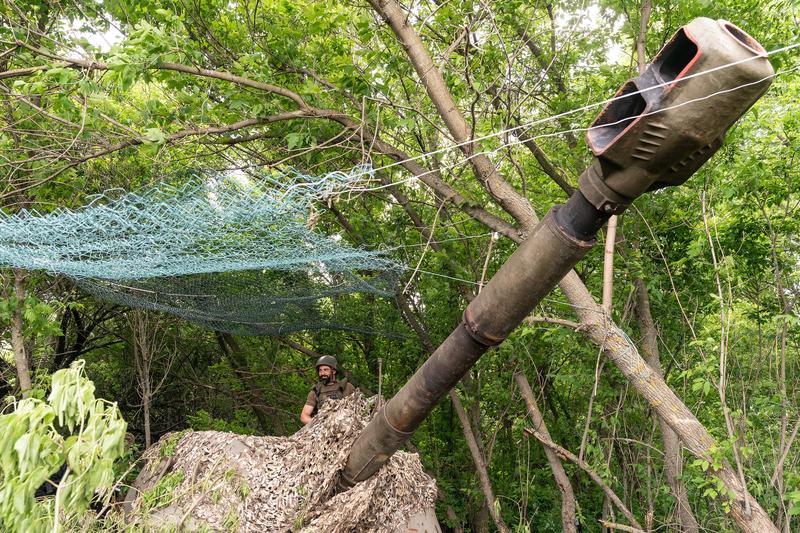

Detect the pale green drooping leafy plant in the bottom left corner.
[{"left": 0, "top": 361, "right": 127, "bottom": 532}]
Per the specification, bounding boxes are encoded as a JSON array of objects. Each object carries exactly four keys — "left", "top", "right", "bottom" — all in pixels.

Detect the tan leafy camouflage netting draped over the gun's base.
[{"left": 130, "top": 393, "right": 436, "bottom": 533}]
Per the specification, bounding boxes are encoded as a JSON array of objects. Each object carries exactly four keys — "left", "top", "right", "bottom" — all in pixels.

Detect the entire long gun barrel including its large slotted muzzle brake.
[{"left": 339, "top": 18, "right": 774, "bottom": 489}]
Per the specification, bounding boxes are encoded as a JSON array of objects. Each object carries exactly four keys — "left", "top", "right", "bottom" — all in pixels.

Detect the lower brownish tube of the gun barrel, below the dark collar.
[{"left": 340, "top": 212, "right": 594, "bottom": 488}]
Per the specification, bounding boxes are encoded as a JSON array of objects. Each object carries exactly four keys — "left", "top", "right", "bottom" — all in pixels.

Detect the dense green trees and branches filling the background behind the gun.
[{"left": 0, "top": 0, "right": 800, "bottom": 532}]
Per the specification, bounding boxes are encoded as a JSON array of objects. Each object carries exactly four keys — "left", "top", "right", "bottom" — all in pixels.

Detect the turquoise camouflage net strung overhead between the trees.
[{"left": 0, "top": 167, "right": 403, "bottom": 335}]
